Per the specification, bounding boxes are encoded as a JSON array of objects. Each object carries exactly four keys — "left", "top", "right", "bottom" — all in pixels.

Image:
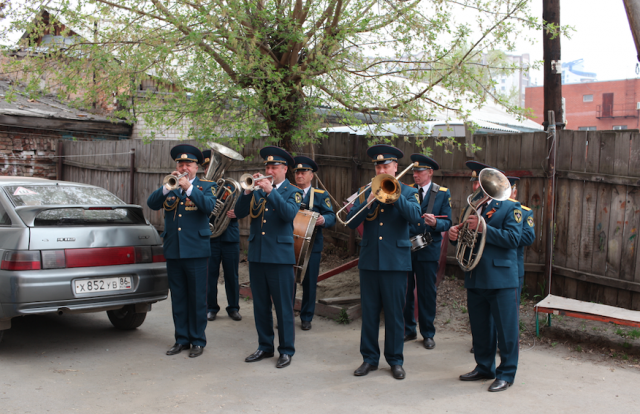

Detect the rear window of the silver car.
[{"left": 5, "top": 185, "right": 145, "bottom": 227}]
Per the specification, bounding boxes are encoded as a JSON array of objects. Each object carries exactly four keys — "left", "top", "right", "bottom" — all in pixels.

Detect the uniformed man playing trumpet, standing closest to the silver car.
[{"left": 147, "top": 144, "right": 216, "bottom": 358}]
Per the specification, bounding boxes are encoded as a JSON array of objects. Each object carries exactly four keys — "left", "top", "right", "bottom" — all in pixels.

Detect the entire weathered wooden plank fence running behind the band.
[{"left": 61, "top": 131, "right": 640, "bottom": 309}]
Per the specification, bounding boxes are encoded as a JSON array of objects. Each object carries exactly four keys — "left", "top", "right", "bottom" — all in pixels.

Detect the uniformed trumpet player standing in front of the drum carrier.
[{"left": 235, "top": 146, "right": 302, "bottom": 368}]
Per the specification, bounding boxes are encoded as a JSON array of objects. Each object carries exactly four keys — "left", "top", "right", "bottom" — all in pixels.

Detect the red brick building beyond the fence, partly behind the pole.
[{"left": 525, "top": 79, "right": 640, "bottom": 131}]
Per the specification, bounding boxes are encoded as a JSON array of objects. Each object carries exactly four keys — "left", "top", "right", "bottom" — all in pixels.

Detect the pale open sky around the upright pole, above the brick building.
[{"left": 515, "top": 0, "right": 639, "bottom": 85}]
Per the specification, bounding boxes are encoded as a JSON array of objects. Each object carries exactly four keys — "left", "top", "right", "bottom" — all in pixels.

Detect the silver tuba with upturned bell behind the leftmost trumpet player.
[{"left": 204, "top": 142, "right": 244, "bottom": 238}]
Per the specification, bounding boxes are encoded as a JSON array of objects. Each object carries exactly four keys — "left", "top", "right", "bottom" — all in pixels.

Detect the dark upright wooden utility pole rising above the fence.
[{"left": 542, "top": 0, "right": 564, "bottom": 131}]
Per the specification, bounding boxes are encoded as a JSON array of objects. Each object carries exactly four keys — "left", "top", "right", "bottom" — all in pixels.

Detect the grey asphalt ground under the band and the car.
[{"left": 0, "top": 289, "right": 640, "bottom": 414}]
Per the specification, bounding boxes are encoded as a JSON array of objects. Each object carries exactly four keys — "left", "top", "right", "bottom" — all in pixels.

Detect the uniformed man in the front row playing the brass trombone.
[{"left": 347, "top": 145, "right": 422, "bottom": 379}]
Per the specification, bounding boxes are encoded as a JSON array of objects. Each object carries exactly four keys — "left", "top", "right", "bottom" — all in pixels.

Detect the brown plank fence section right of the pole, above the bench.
[{"left": 551, "top": 131, "right": 640, "bottom": 310}]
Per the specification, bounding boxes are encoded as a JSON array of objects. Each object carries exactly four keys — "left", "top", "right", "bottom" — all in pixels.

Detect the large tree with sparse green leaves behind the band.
[{"left": 0, "top": 0, "right": 539, "bottom": 150}]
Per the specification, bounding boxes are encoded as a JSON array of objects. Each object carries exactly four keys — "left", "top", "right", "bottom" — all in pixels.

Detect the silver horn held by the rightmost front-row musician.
[{"left": 456, "top": 168, "right": 511, "bottom": 272}]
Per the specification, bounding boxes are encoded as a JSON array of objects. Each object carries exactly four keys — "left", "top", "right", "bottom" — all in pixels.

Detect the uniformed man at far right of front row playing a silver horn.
[{"left": 449, "top": 161, "right": 522, "bottom": 392}]
